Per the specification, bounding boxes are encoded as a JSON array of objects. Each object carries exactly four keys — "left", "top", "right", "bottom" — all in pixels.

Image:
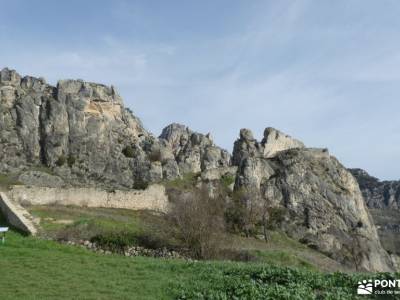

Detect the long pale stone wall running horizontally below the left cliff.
[{"left": 8, "top": 184, "right": 168, "bottom": 211}]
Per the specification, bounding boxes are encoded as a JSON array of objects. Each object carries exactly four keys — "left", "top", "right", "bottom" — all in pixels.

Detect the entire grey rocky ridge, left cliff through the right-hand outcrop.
[{"left": 0, "top": 69, "right": 392, "bottom": 271}]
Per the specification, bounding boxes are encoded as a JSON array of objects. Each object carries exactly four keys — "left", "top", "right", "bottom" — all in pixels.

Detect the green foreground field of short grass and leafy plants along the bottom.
[{"left": 0, "top": 232, "right": 388, "bottom": 300}]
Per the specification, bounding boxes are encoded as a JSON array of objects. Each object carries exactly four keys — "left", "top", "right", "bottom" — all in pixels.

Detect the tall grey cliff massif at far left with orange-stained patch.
[{"left": 0, "top": 69, "right": 163, "bottom": 188}]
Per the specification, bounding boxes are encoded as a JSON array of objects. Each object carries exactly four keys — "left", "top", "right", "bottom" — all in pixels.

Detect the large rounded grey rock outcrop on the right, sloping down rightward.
[{"left": 233, "top": 129, "right": 392, "bottom": 271}]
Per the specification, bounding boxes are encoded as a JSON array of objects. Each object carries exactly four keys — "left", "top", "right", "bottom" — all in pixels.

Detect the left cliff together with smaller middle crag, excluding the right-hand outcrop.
[{"left": 0, "top": 68, "right": 230, "bottom": 188}]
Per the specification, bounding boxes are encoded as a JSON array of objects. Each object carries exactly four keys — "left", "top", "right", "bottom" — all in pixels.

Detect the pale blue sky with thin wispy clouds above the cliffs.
[{"left": 0, "top": 0, "right": 400, "bottom": 179}]
